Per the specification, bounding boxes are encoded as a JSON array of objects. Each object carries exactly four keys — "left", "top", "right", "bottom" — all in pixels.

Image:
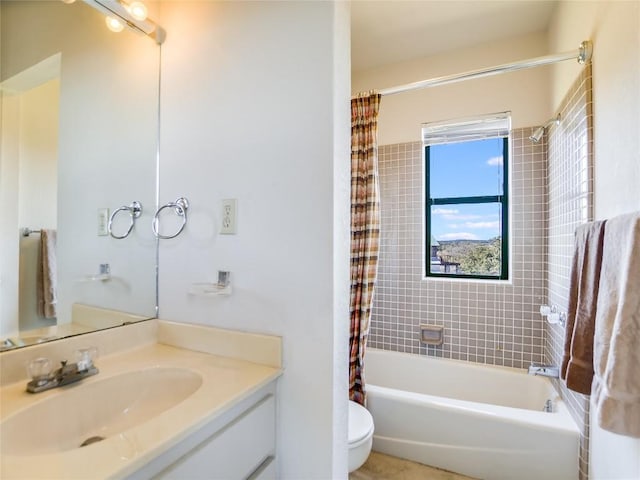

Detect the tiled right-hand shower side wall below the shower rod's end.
[{"left": 545, "top": 66, "right": 593, "bottom": 480}]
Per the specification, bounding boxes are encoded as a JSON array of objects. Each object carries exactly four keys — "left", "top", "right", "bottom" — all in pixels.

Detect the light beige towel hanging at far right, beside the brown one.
[{"left": 591, "top": 212, "right": 640, "bottom": 438}]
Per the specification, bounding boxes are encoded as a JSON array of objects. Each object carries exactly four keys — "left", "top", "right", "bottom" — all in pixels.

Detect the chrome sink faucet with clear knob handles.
[{"left": 27, "top": 349, "right": 98, "bottom": 393}]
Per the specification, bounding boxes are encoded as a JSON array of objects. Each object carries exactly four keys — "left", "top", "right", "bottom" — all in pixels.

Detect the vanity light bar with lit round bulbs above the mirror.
[{"left": 73, "top": 0, "right": 165, "bottom": 44}]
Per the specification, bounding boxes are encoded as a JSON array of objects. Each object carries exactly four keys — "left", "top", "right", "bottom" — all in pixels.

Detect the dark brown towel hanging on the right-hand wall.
[{"left": 560, "top": 221, "right": 605, "bottom": 395}]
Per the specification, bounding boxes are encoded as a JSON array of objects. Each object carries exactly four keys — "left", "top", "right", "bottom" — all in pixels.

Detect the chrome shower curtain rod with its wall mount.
[{"left": 379, "top": 40, "right": 593, "bottom": 96}]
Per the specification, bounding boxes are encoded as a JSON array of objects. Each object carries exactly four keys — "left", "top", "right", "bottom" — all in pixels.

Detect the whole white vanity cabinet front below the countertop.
[{"left": 128, "top": 381, "right": 276, "bottom": 480}]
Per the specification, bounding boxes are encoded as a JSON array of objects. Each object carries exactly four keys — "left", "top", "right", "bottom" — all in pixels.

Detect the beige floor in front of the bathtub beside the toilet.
[{"left": 349, "top": 452, "right": 473, "bottom": 480}]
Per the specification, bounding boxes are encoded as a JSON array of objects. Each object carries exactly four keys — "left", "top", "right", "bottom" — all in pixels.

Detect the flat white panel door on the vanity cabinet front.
[{"left": 155, "top": 395, "right": 275, "bottom": 480}]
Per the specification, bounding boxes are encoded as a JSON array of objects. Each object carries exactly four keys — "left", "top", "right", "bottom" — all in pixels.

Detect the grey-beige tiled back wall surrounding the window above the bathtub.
[{"left": 368, "top": 128, "right": 547, "bottom": 368}]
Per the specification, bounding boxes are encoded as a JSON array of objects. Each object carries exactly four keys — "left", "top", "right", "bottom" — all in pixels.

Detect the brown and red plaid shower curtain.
[{"left": 349, "top": 92, "right": 380, "bottom": 405}]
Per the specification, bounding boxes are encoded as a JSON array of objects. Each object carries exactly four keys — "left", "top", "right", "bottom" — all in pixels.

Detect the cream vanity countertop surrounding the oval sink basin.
[{"left": 0, "top": 343, "right": 282, "bottom": 479}]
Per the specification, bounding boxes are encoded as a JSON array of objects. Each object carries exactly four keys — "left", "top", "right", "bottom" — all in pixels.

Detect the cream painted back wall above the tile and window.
[{"left": 351, "top": 32, "right": 551, "bottom": 145}]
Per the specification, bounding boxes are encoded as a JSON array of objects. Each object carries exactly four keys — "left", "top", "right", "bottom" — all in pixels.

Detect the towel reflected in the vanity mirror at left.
[{"left": 36, "top": 228, "right": 58, "bottom": 318}]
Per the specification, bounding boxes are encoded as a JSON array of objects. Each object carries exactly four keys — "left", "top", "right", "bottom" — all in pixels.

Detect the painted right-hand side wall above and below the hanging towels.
[{"left": 549, "top": 1, "right": 640, "bottom": 480}]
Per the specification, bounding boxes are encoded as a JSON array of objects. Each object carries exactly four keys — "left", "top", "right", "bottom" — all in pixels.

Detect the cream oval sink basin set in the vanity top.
[{"left": 0, "top": 368, "right": 202, "bottom": 456}]
